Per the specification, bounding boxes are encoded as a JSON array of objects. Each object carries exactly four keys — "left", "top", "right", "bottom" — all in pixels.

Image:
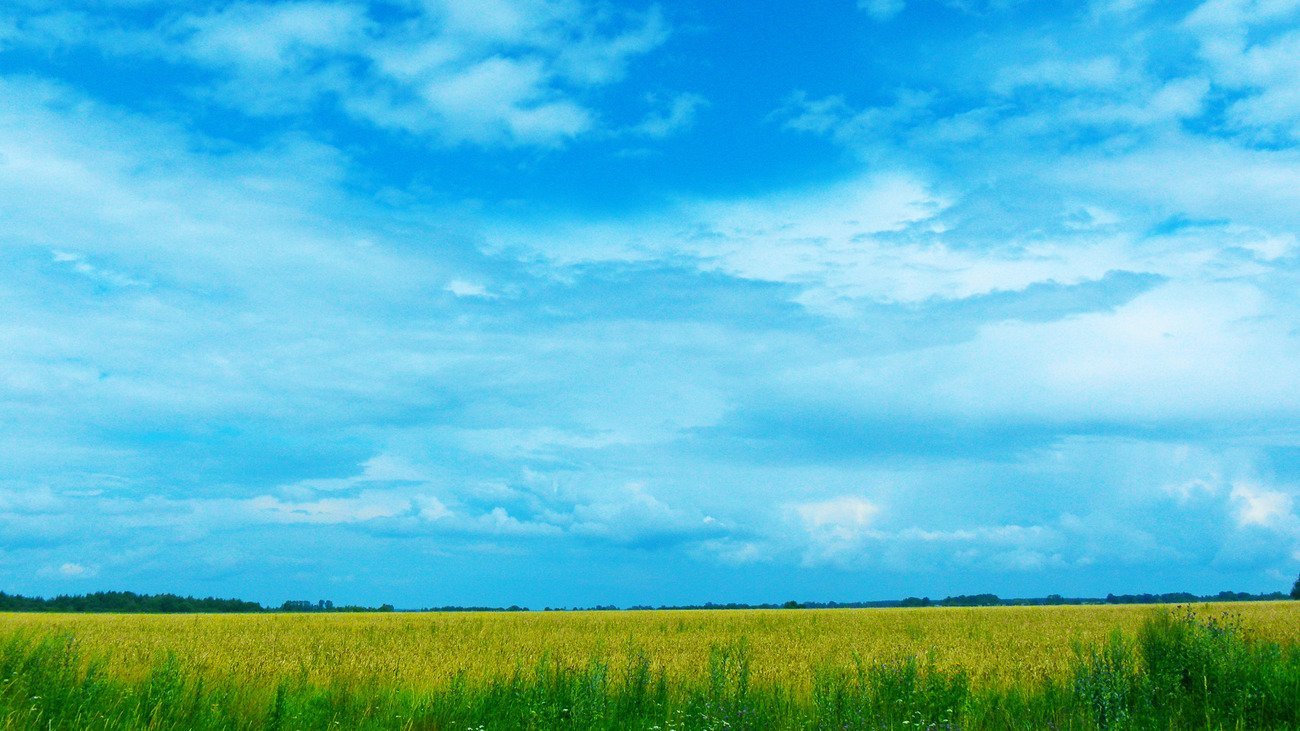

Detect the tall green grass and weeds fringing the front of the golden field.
[{"left": 0, "top": 610, "right": 1300, "bottom": 730}]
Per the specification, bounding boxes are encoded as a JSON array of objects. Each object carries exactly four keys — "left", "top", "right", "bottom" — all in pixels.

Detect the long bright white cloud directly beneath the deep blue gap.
[{"left": 493, "top": 176, "right": 1008, "bottom": 303}]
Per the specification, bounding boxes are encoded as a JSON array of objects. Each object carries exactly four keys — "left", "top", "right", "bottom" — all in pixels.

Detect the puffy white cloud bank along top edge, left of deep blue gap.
[{"left": 9, "top": 0, "right": 681, "bottom": 146}]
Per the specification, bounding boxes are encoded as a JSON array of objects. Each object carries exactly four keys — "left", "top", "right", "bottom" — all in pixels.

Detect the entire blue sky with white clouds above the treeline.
[{"left": 0, "top": 0, "right": 1300, "bottom": 609}]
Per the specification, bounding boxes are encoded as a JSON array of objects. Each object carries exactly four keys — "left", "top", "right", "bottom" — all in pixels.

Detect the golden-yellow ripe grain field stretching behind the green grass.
[{"left": 0, "top": 602, "right": 1300, "bottom": 692}]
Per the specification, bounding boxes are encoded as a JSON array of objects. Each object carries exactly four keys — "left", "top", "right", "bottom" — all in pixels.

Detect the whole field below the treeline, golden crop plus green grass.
[{"left": 0, "top": 602, "right": 1300, "bottom": 728}]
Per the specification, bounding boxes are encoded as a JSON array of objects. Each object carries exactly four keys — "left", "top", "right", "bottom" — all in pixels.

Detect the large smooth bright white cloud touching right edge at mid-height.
[{"left": 832, "top": 277, "right": 1300, "bottom": 423}]
